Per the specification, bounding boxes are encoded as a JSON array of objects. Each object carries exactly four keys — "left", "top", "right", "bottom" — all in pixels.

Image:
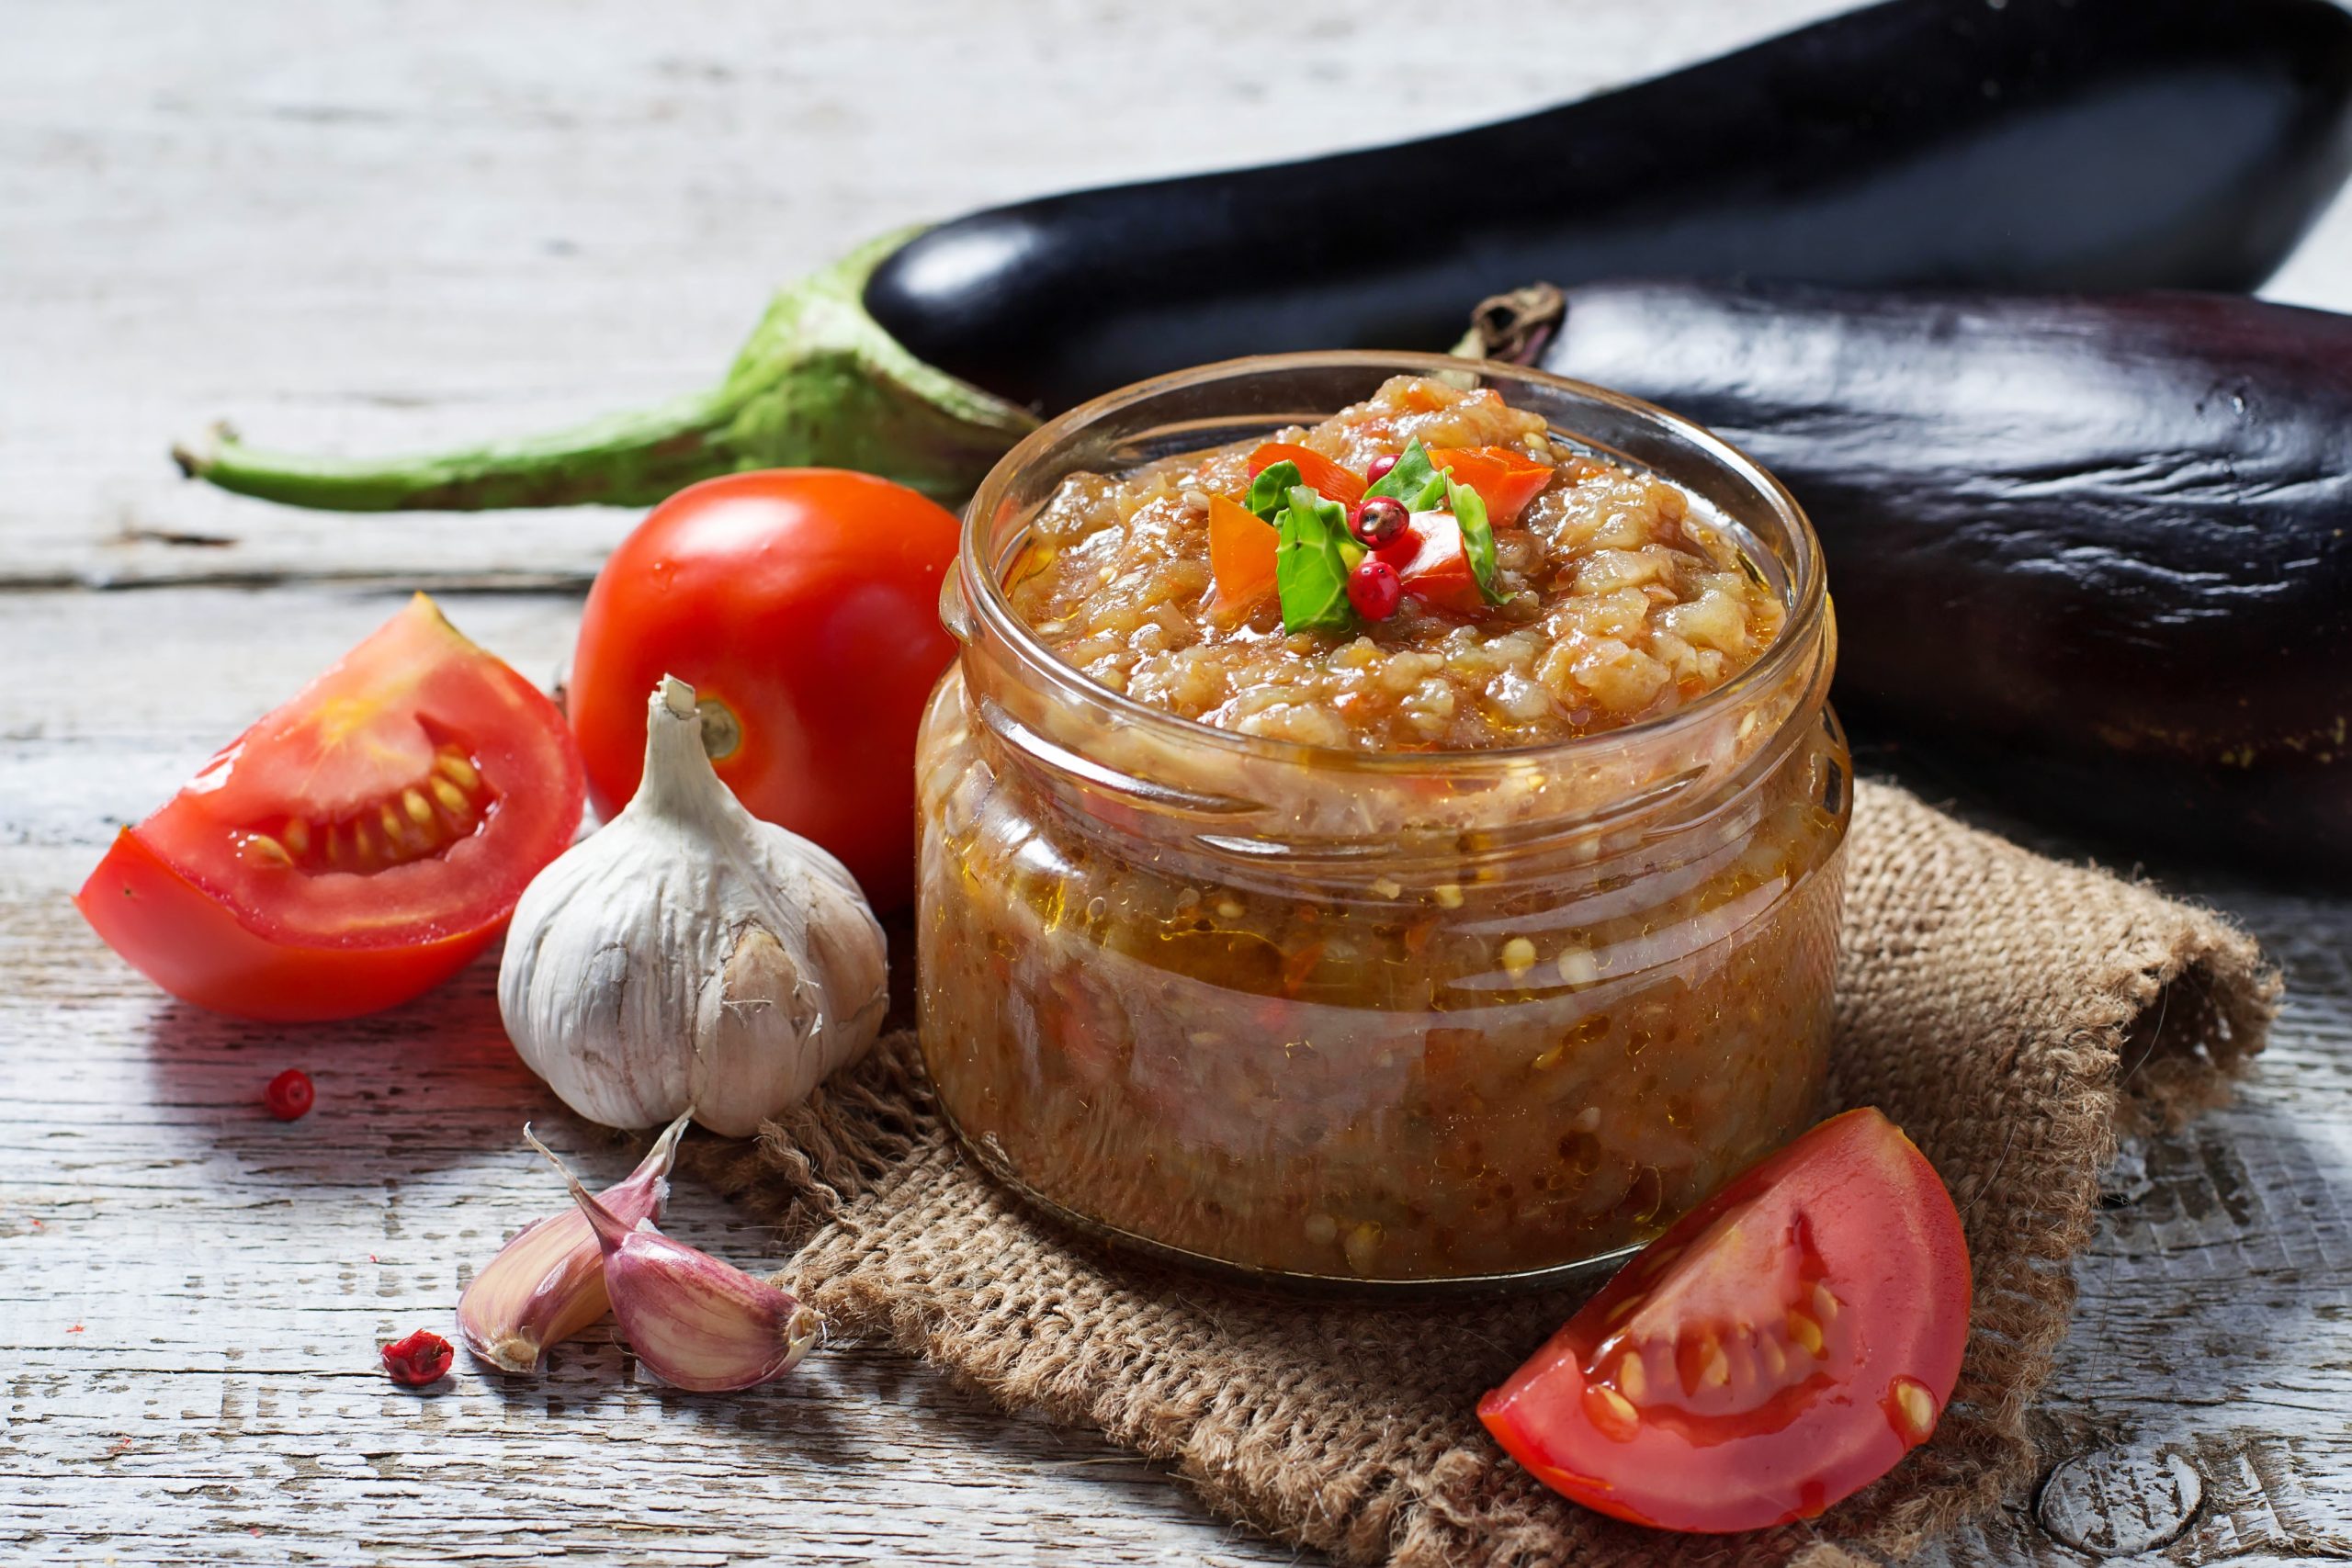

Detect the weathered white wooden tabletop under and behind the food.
[{"left": 0, "top": 0, "right": 2352, "bottom": 1568}]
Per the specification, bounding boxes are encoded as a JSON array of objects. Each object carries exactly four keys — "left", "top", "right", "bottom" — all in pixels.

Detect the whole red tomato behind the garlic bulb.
[{"left": 570, "top": 468, "right": 957, "bottom": 909}]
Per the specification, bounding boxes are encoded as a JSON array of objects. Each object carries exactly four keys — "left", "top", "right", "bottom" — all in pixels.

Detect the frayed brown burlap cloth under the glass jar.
[{"left": 703, "top": 785, "right": 2277, "bottom": 1568}]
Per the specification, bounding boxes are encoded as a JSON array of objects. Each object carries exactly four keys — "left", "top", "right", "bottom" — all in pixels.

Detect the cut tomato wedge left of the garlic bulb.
[{"left": 73, "top": 594, "right": 581, "bottom": 1022}]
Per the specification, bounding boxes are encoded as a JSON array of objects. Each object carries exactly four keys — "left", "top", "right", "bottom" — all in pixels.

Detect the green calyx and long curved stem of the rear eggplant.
[{"left": 172, "top": 231, "right": 1037, "bottom": 513}]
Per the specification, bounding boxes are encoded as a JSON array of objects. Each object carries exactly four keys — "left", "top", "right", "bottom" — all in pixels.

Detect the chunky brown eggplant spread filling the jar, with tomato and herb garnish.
[{"left": 917, "top": 376, "right": 1847, "bottom": 1281}]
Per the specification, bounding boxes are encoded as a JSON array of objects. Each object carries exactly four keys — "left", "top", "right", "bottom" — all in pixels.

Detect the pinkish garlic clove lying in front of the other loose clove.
[{"left": 538, "top": 1147, "right": 823, "bottom": 1394}]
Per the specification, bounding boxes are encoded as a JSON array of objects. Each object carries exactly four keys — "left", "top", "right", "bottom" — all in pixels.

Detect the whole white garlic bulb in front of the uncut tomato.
[{"left": 499, "top": 677, "right": 889, "bottom": 1138}]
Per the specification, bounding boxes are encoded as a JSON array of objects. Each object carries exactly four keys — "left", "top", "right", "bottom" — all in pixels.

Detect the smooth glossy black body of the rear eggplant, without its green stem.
[{"left": 865, "top": 0, "right": 2352, "bottom": 412}]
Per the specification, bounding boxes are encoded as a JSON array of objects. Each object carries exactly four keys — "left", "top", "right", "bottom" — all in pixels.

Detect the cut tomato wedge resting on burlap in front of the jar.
[{"left": 1477, "top": 1110, "right": 1969, "bottom": 1533}]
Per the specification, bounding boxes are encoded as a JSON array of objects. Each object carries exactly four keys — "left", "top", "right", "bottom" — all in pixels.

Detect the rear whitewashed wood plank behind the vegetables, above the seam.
[{"left": 0, "top": 0, "right": 1837, "bottom": 594}]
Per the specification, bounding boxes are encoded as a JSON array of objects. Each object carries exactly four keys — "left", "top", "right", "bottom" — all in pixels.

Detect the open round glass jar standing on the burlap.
[{"left": 917, "top": 353, "right": 1849, "bottom": 1286}]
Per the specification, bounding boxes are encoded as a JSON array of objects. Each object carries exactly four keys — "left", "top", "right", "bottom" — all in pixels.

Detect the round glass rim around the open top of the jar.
[{"left": 950, "top": 348, "right": 1830, "bottom": 773}]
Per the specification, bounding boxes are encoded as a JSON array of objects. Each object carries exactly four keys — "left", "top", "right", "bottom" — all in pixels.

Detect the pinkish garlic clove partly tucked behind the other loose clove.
[{"left": 457, "top": 1117, "right": 689, "bottom": 1373}]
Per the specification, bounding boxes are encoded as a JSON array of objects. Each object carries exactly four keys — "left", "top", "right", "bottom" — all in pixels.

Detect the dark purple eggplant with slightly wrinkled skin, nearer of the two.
[{"left": 1541, "top": 282, "right": 2352, "bottom": 879}]
